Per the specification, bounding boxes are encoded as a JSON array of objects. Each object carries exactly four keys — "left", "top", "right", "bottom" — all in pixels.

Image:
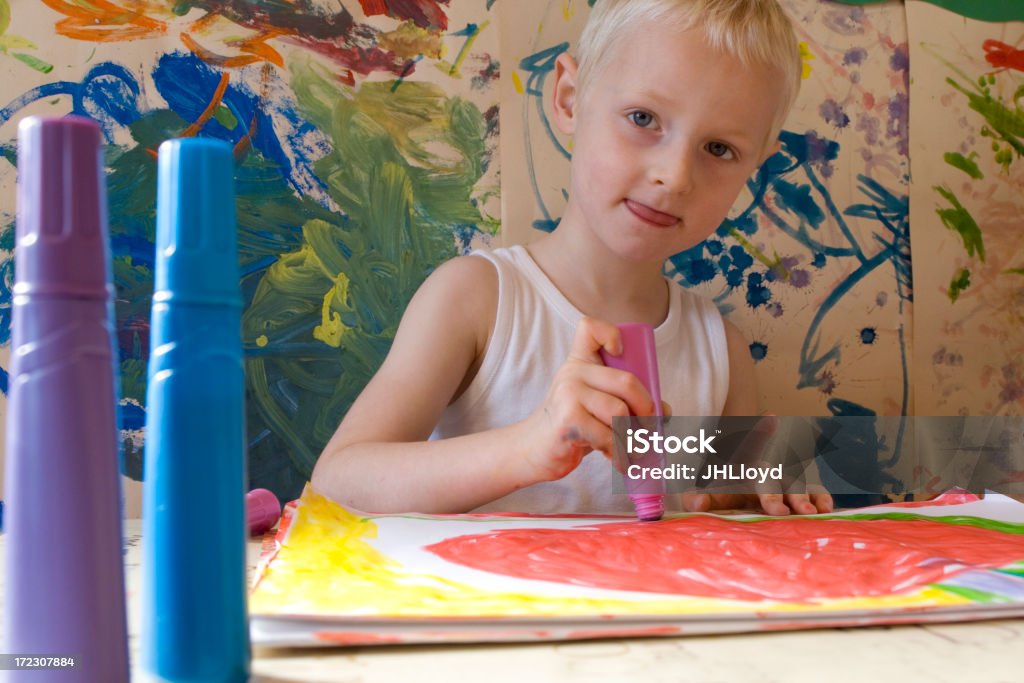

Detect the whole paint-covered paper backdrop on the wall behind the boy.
[{"left": 0, "top": 0, "right": 1024, "bottom": 509}]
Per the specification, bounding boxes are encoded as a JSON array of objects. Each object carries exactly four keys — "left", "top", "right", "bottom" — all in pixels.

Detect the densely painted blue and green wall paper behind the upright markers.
[{"left": 0, "top": 0, "right": 500, "bottom": 501}]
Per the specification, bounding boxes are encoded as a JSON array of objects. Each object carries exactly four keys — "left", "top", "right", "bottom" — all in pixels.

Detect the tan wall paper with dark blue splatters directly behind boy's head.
[{"left": 501, "top": 0, "right": 913, "bottom": 415}]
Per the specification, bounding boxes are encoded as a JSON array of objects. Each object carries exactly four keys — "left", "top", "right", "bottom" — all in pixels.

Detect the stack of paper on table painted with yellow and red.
[{"left": 250, "top": 490, "right": 1024, "bottom": 644}]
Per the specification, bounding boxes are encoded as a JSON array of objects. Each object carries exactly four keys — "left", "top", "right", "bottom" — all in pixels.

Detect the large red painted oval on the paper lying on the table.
[{"left": 426, "top": 515, "right": 1024, "bottom": 603}]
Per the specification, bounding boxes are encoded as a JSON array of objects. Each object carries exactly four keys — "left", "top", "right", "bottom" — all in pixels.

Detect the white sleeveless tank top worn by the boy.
[{"left": 431, "top": 246, "right": 729, "bottom": 514}]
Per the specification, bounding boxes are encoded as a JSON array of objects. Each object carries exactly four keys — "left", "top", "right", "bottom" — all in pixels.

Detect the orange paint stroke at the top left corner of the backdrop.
[{"left": 43, "top": 0, "right": 167, "bottom": 43}]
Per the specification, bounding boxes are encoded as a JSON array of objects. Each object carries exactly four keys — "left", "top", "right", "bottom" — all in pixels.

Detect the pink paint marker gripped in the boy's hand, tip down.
[{"left": 601, "top": 323, "right": 665, "bottom": 521}]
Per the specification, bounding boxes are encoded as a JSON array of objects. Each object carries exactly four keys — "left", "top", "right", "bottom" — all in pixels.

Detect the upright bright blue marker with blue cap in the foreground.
[{"left": 140, "top": 138, "right": 250, "bottom": 683}]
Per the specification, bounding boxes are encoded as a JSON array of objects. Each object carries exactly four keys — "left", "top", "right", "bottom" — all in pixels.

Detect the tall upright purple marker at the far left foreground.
[{"left": 0, "top": 117, "right": 128, "bottom": 683}]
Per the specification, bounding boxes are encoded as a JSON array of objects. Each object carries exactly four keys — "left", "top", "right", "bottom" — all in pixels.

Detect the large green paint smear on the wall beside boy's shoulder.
[{"left": 239, "top": 60, "right": 486, "bottom": 485}]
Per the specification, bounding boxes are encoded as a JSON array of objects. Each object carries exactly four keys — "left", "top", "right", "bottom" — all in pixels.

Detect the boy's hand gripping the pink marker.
[{"left": 521, "top": 317, "right": 655, "bottom": 481}]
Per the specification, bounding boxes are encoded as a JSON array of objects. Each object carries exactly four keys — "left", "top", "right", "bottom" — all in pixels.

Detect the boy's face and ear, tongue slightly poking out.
[{"left": 554, "top": 20, "right": 782, "bottom": 263}]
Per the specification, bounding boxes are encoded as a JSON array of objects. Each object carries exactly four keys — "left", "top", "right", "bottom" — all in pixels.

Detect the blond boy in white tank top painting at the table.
[{"left": 312, "top": 0, "right": 831, "bottom": 514}]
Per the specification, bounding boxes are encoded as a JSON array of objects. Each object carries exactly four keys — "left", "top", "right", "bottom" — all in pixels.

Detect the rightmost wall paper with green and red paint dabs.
[{"left": 907, "top": 2, "right": 1024, "bottom": 415}]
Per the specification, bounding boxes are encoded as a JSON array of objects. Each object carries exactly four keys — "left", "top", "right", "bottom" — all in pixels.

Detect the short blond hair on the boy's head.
[{"left": 577, "top": 0, "right": 803, "bottom": 141}]
